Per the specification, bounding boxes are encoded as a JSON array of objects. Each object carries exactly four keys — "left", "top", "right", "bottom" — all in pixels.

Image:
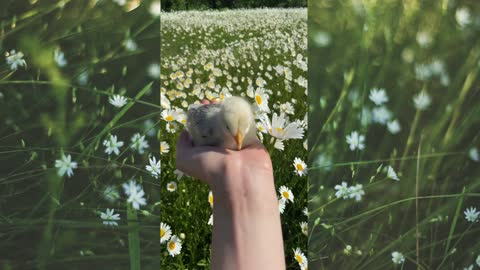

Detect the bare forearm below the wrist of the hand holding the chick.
[{"left": 211, "top": 172, "right": 285, "bottom": 270}]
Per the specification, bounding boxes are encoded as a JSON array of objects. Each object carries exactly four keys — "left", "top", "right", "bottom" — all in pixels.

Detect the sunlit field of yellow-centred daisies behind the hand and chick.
[{"left": 159, "top": 9, "right": 308, "bottom": 269}]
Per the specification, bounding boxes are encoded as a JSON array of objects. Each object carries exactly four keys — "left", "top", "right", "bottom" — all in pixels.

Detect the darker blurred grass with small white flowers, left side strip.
[{"left": 0, "top": 0, "right": 160, "bottom": 269}]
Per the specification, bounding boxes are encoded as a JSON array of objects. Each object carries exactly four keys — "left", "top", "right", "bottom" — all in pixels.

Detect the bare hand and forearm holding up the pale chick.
[{"left": 176, "top": 101, "right": 285, "bottom": 270}]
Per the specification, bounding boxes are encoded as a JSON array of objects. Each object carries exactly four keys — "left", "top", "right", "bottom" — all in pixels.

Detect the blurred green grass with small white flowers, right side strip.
[{"left": 308, "top": 0, "right": 480, "bottom": 270}]
